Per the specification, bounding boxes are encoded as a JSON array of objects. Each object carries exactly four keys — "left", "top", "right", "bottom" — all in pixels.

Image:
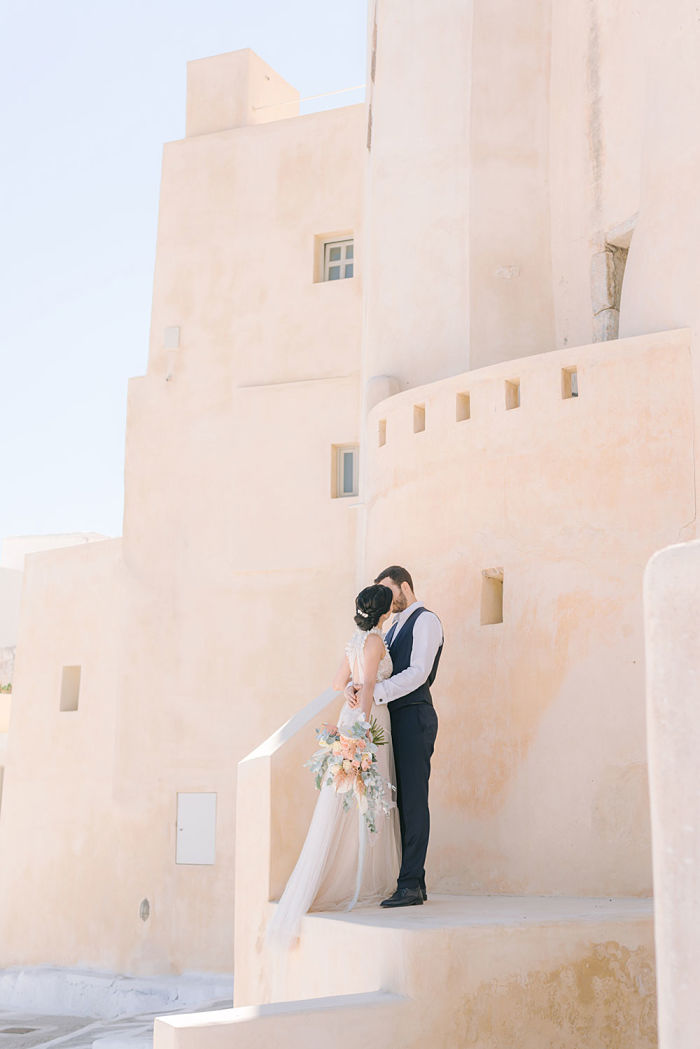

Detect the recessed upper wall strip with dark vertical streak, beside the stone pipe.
[{"left": 549, "top": 0, "right": 650, "bottom": 347}]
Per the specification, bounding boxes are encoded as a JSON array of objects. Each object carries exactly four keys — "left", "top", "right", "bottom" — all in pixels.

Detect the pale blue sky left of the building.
[{"left": 0, "top": 0, "right": 366, "bottom": 537}]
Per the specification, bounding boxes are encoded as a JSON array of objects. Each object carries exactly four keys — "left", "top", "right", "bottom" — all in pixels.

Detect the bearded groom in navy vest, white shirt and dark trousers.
[{"left": 345, "top": 564, "right": 443, "bottom": 907}]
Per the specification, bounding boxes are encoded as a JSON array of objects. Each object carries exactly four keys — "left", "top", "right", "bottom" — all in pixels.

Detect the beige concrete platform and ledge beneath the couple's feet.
[{"left": 155, "top": 896, "right": 656, "bottom": 1049}]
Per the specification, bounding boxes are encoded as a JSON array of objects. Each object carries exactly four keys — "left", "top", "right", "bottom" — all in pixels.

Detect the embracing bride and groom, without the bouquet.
[{"left": 268, "top": 565, "right": 443, "bottom": 945}]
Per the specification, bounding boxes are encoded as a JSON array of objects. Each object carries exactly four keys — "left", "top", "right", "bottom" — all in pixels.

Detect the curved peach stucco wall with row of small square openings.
[{"left": 365, "top": 331, "right": 695, "bottom": 895}]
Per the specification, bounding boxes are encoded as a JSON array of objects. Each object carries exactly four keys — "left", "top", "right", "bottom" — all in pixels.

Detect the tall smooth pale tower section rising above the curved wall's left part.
[{"left": 362, "top": 0, "right": 554, "bottom": 403}]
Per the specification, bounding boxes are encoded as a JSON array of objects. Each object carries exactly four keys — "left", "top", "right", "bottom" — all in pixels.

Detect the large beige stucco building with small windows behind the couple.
[{"left": 0, "top": 0, "right": 700, "bottom": 1049}]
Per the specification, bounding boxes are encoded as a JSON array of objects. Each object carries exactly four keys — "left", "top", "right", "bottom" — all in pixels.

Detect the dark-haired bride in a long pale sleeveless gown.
[{"left": 268, "top": 584, "right": 400, "bottom": 946}]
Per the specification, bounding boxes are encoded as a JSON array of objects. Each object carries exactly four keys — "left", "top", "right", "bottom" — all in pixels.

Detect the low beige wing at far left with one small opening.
[{"left": 0, "top": 540, "right": 123, "bottom": 967}]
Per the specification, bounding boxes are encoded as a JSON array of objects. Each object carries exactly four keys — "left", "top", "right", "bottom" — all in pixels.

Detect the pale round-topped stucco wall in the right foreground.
[{"left": 644, "top": 542, "right": 700, "bottom": 1049}]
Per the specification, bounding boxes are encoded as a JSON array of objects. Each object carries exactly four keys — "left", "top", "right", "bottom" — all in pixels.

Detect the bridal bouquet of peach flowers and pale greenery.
[{"left": 305, "top": 715, "right": 396, "bottom": 834}]
